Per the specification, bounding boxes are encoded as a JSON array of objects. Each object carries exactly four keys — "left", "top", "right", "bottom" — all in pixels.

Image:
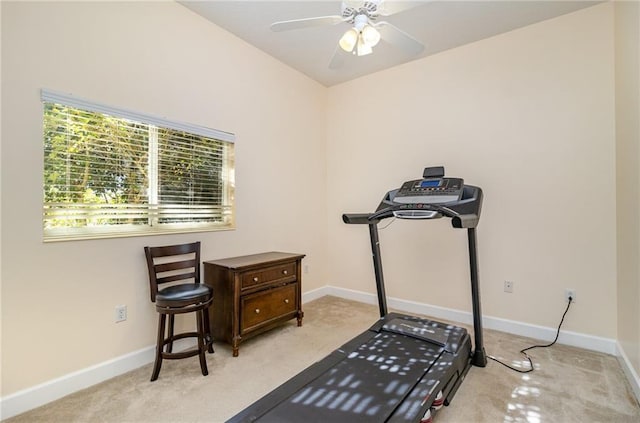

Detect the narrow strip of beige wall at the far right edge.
[{"left": 615, "top": 2, "right": 640, "bottom": 374}]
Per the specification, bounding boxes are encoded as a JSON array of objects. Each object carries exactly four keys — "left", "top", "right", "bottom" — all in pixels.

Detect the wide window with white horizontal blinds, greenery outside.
[{"left": 42, "top": 90, "right": 235, "bottom": 241}]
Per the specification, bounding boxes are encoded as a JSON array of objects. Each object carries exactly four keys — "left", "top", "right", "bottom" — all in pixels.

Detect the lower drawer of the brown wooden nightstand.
[{"left": 240, "top": 283, "right": 298, "bottom": 334}]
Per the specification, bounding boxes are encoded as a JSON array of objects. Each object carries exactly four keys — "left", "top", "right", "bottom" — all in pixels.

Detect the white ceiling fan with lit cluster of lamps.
[{"left": 271, "top": 0, "right": 424, "bottom": 69}]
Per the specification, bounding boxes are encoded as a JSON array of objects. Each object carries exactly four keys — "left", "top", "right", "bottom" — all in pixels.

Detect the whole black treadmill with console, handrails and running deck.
[{"left": 228, "top": 166, "right": 487, "bottom": 423}]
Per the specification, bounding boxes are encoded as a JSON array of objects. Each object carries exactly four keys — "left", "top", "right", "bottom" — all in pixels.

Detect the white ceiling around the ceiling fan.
[{"left": 179, "top": 0, "right": 599, "bottom": 86}]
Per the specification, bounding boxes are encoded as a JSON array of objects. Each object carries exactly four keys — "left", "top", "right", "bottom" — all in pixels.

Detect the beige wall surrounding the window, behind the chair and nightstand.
[{"left": 2, "top": 2, "right": 327, "bottom": 396}]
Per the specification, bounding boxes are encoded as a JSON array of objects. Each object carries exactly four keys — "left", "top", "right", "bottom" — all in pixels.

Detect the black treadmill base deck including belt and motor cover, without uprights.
[{"left": 229, "top": 313, "right": 471, "bottom": 423}]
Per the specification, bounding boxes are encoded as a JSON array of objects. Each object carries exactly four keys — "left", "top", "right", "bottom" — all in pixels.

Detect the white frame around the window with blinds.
[{"left": 41, "top": 88, "right": 235, "bottom": 242}]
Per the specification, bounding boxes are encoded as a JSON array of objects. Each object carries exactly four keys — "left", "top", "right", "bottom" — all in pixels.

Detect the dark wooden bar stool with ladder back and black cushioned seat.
[{"left": 144, "top": 242, "right": 214, "bottom": 382}]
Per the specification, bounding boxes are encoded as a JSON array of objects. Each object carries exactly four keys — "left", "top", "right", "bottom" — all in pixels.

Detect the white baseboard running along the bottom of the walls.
[{"left": 0, "top": 286, "right": 640, "bottom": 420}]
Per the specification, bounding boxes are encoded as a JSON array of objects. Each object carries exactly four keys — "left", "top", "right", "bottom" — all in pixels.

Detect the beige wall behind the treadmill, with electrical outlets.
[{"left": 327, "top": 4, "right": 617, "bottom": 338}]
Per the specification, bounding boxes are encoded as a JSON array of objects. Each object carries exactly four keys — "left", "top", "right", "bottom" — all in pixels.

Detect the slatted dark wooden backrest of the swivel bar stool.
[{"left": 144, "top": 241, "right": 200, "bottom": 302}]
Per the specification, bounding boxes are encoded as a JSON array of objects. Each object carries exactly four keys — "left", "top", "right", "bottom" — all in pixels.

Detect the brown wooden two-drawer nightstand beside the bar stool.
[{"left": 204, "top": 252, "right": 305, "bottom": 357}]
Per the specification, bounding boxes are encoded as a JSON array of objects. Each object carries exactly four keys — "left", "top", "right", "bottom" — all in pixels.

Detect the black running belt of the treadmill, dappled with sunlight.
[{"left": 260, "top": 331, "right": 444, "bottom": 423}]
